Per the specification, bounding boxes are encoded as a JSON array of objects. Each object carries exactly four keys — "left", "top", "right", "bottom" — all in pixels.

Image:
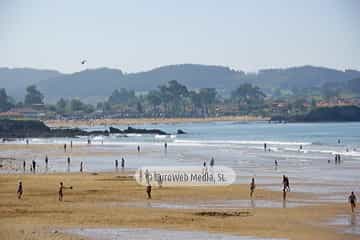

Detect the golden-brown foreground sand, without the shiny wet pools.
[{"left": 0, "top": 172, "right": 359, "bottom": 239}]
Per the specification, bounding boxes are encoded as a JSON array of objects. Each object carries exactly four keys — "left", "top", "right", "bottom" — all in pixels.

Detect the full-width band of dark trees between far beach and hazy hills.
[{"left": 0, "top": 79, "right": 360, "bottom": 117}]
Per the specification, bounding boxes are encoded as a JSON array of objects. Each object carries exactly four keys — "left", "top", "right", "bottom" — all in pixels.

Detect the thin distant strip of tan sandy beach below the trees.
[{"left": 44, "top": 116, "right": 270, "bottom": 127}]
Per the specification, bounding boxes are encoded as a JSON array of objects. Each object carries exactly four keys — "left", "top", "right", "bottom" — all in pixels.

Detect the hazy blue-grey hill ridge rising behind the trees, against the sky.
[{"left": 0, "top": 64, "right": 360, "bottom": 102}]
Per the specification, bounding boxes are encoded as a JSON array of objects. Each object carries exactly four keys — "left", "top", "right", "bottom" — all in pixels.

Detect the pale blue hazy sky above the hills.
[{"left": 0, "top": 0, "right": 360, "bottom": 72}]
